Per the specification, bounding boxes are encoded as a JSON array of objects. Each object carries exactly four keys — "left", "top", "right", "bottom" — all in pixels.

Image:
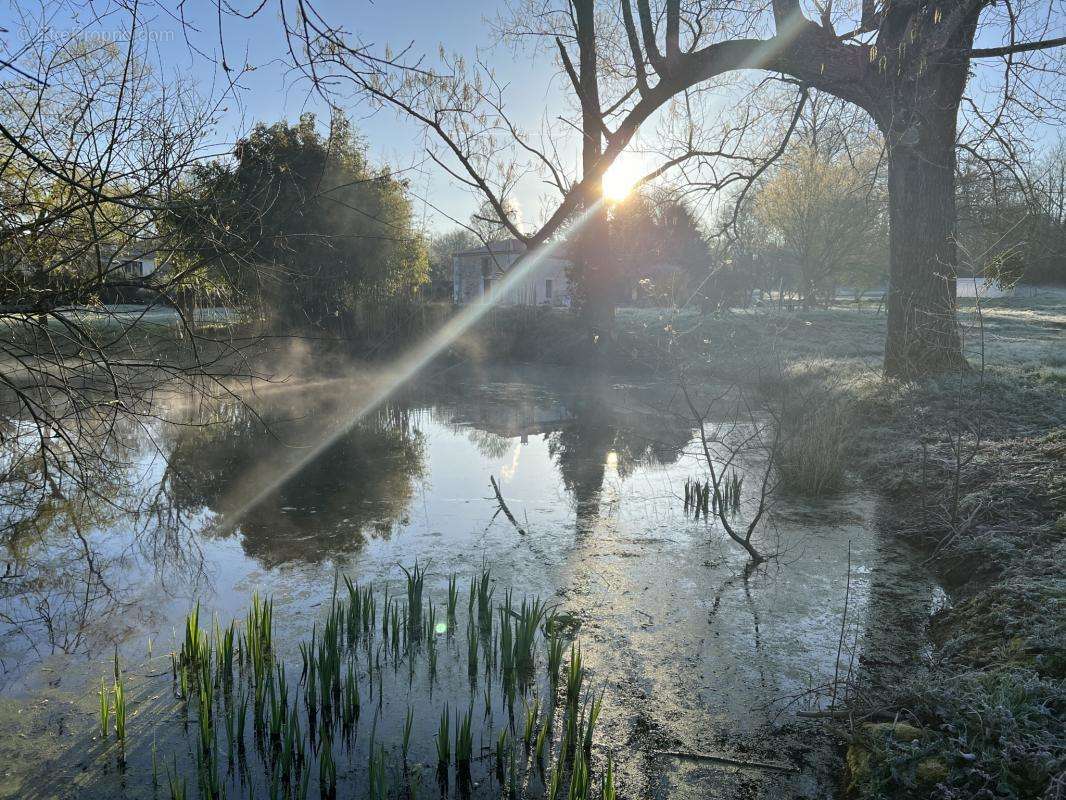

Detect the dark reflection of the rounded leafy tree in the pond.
[{"left": 162, "top": 403, "right": 424, "bottom": 567}]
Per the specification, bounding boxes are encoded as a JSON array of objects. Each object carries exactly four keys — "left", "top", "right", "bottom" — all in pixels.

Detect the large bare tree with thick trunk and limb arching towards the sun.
[{"left": 260, "top": 0, "right": 1066, "bottom": 375}]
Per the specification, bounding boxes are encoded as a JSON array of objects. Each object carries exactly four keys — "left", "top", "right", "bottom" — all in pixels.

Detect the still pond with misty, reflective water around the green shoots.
[{"left": 0, "top": 368, "right": 940, "bottom": 798}]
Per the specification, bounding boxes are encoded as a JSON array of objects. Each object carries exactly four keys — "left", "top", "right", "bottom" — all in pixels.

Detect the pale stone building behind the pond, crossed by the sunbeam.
[{"left": 452, "top": 239, "right": 570, "bottom": 306}]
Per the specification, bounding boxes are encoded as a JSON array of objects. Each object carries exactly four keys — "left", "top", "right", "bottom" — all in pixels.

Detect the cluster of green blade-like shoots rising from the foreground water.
[{"left": 119, "top": 564, "right": 622, "bottom": 800}]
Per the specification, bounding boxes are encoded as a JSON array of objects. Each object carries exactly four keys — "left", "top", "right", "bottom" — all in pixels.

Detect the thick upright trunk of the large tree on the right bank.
[{"left": 885, "top": 104, "right": 967, "bottom": 378}]
